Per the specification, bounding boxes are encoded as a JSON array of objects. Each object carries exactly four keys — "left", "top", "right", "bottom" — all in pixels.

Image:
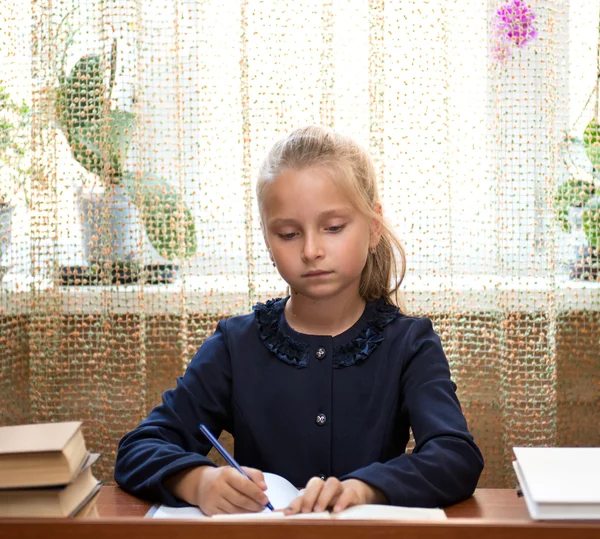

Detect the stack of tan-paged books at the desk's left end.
[{"left": 0, "top": 421, "right": 102, "bottom": 517}]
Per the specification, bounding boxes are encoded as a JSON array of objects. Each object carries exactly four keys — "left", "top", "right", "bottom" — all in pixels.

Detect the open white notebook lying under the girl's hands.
[{"left": 147, "top": 473, "right": 446, "bottom": 520}]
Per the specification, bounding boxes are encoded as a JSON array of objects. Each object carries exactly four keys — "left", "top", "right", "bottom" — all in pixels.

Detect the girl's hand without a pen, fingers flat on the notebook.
[{"left": 284, "top": 477, "right": 387, "bottom": 515}]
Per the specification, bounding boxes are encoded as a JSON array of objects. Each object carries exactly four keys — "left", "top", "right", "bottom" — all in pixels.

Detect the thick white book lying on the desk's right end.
[{"left": 513, "top": 447, "right": 600, "bottom": 520}]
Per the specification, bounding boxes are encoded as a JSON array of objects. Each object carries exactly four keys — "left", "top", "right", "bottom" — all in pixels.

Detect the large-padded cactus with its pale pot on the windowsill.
[{"left": 56, "top": 40, "right": 197, "bottom": 284}]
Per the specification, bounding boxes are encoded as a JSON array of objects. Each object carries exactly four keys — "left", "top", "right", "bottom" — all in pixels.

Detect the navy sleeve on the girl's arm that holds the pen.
[{"left": 115, "top": 320, "right": 231, "bottom": 507}]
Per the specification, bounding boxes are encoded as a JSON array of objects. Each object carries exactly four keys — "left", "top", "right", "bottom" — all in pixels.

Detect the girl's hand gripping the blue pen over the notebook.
[{"left": 166, "top": 466, "right": 268, "bottom": 516}]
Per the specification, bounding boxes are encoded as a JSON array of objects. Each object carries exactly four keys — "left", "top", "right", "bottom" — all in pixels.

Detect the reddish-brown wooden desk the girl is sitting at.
[{"left": 0, "top": 487, "right": 600, "bottom": 539}]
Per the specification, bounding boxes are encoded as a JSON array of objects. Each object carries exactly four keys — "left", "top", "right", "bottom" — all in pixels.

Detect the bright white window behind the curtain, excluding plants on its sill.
[{"left": 2, "top": 0, "right": 598, "bottom": 296}]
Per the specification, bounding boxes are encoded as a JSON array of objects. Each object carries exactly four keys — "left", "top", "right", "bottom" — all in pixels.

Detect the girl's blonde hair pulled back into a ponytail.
[{"left": 256, "top": 126, "right": 406, "bottom": 309}]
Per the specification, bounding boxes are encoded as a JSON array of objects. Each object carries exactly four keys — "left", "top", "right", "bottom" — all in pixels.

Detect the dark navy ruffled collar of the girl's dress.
[{"left": 253, "top": 298, "right": 399, "bottom": 369}]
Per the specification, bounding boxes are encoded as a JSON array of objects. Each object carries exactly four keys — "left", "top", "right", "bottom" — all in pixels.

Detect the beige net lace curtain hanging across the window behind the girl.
[{"left": 0, "top": 0, "right": 600, "bottom": 487}]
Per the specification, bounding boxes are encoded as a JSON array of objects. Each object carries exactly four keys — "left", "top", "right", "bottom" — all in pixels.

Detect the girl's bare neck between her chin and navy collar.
[{"left": 285, "top": 284, "right": 365, "bottom": 336}]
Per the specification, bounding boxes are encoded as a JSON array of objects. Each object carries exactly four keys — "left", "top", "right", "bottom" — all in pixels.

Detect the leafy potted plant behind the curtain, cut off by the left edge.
[{"left": 0, "top": 84, "right": 31, "bottom": 280}]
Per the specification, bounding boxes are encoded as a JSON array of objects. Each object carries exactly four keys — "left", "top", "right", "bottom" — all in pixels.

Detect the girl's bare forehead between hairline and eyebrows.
[{"left": 262, "top": 167, "right": 352, "bottom": 219}]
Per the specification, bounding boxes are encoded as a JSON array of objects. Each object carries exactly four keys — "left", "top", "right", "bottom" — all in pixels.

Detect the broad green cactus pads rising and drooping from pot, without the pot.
[{"left": 56, "top": 41, "right": 197, "bottom": 261}]
